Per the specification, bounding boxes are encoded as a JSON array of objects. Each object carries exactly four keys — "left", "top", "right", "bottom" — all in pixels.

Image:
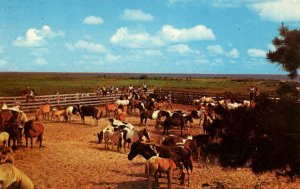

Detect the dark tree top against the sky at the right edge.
[{"left": 267, "top": 23, "right": 300, "bottom": 79}]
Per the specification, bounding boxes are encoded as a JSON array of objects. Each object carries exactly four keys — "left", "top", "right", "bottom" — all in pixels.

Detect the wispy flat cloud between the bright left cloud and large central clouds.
[{"left": 66, "top": 40, "right": 107, "bottom": 53}]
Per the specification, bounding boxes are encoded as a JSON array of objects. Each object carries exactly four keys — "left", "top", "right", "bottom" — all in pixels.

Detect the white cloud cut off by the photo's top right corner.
[{"left": 251, "top": 0, "right": 300, "bottom": 22}]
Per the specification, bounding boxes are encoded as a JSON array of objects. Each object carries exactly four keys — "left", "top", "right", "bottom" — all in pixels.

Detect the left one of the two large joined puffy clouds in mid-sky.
[{"left": 110, "top": 27, "right": 164, "bottom": 48}]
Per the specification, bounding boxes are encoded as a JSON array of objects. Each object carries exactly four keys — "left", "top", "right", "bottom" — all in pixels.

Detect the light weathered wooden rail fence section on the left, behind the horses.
[{"left": 0, "top": 89, "right": 154, "bottom": 113}]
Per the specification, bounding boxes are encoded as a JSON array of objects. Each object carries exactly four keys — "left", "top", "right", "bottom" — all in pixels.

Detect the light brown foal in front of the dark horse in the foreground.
[{"left": 145, "top": 156, "right": 176, "bottom": 189}]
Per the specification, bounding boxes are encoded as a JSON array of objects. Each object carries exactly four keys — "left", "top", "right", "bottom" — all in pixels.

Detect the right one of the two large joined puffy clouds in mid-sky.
[{"left": 159, "top": 25, "right": 215, "bottom": 42}]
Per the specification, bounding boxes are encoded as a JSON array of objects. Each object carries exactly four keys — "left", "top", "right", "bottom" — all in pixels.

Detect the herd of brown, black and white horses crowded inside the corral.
[{"left": 0, "top": 91, "right": 258, "bottom": 188}]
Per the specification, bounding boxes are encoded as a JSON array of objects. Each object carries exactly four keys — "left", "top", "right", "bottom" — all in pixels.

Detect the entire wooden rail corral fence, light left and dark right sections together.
[{"left": 0, "top": 89, "right": 300, "bottom": 113}]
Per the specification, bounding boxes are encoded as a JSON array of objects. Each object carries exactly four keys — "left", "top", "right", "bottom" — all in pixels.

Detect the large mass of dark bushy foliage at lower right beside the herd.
[{"left": 204, "top": 94, "right": 300, "bottom": 175}]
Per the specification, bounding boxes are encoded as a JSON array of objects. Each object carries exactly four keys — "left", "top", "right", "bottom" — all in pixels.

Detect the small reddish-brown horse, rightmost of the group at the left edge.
[{"left": 24, "top": 120, "right": 44, "bottom": 148}]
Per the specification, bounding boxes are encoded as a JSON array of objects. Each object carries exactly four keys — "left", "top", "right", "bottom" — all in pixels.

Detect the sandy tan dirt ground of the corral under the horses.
[{"left": 9, "top": 105, "right": 300, "bottom": 189}]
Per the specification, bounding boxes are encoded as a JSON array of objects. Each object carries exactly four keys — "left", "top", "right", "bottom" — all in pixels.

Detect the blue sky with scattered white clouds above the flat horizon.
[{"left": 0, "top": 0, "right": 300, "bottom": 74}]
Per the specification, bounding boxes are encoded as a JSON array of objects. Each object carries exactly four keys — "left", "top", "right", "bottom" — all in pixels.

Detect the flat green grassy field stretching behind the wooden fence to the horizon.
[{"left": 0, "top": 73, "right": 279, "bottom": 96}]
